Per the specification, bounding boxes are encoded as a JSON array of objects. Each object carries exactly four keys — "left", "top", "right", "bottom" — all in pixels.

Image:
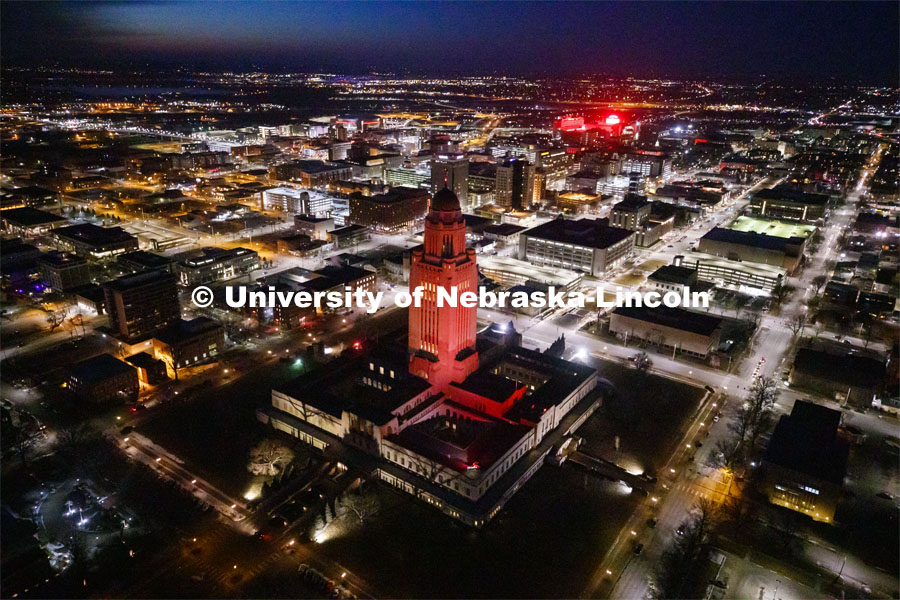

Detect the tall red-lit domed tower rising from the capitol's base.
[{"left": 409, "top": 187, "right": 478, "bottom": 390}]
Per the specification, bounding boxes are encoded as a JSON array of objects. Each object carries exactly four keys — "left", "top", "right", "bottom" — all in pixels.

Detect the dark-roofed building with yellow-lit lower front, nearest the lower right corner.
[{"left": 761, "top": 400, "right": 849, "bottom": 523}]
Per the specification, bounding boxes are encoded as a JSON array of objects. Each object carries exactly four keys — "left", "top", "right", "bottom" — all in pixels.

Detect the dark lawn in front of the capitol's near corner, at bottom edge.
[{"left": 315, "top": 465, "right": 639, "bottom": 598}]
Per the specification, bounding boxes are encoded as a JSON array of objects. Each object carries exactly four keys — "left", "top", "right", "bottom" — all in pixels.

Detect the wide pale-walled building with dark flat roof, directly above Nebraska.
[{"left": 518, "top": 219, "right": 635, "bottom": 277}]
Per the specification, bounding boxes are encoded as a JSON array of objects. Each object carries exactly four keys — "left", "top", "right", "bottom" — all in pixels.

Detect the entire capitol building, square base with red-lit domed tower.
[{"left": 257, "top": 189, "right": 600, "bottom": 527}]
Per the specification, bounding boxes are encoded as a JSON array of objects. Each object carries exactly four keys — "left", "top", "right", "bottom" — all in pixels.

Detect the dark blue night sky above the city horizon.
[{"left": 0, "top": 2, "right": 900, "bottom": 85}]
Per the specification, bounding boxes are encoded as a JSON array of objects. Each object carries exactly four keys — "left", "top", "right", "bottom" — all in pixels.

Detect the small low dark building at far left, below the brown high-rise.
[{"left": 66, "top": 354, "right": 140, "bottom": 403}]
